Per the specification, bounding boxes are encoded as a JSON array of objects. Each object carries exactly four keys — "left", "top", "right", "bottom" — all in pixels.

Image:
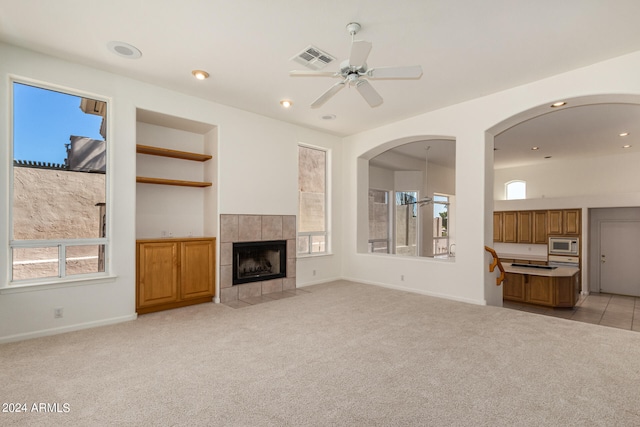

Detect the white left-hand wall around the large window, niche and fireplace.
[{"left": 0, "top": 44, "right": 342, "bottom": 342}]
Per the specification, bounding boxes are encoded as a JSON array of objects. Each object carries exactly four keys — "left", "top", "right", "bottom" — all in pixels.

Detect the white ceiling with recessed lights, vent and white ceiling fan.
[{"left": 0, "top": 0, "right": 640, "bottom": 167}]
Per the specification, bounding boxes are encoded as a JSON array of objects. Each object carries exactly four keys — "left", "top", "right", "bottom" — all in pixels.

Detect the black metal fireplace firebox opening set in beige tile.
[{"left": 233, "top": 240, "right": 287, "bottom": 285}]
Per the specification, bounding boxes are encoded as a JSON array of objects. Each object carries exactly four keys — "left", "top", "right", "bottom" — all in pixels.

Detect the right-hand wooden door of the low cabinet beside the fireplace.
[{"left": 180, "top": 240, "right": 215, "bottom": 299}]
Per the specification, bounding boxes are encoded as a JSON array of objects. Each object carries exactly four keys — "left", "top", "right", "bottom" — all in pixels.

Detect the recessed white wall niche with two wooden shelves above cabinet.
[{"left": 136, "top": 109, "right": 218, "bottom": 239}]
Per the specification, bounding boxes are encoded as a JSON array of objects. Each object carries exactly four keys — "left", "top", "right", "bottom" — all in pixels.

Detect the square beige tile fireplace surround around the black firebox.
[{"left": 220, "top": 215, "right": 296, "bottom": 303}]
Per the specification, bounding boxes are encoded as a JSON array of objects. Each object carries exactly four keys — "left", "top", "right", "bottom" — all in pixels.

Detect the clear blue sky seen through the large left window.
[{"left": 13, "top": 83, "right": 104, "bottom": 164}]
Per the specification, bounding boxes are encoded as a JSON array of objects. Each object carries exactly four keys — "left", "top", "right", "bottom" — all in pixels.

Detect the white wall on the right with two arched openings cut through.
[{"left": 343, "top": 48, "right": 640, "bottom": 305}]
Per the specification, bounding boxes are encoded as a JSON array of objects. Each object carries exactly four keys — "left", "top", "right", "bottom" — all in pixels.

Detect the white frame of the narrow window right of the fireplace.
[{"left": 296, "top": 143, "right": 332, "bottom": 258}]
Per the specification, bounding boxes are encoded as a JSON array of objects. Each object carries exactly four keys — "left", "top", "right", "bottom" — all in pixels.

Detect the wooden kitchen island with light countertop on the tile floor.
[{"left": 502, "top": 263, "right": 580, "bottom": 307}]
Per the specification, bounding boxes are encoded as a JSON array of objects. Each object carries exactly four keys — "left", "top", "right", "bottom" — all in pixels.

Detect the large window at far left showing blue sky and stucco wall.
[{"left": 9, "top": 82, "right": 108, "bottom": 283}]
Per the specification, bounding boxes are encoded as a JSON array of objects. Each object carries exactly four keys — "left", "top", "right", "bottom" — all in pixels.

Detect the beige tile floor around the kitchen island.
[{"left": 503, "top": 294, "right": 640, "bottom": 332}]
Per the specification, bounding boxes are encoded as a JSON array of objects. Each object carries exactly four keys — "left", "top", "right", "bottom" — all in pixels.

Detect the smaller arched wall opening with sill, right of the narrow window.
[{"left": 358, "top": 136, "right": 456, "bottom": 259}]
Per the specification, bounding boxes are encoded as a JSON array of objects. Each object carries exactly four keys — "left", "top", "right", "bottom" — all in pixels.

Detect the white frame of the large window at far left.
[{"left": 6, "top": 75, "right": 113, "bottom": 291}]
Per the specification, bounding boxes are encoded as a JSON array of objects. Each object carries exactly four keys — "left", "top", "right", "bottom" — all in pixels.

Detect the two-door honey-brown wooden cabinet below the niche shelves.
[{"left": 136, "top": 238, "right": 215, "bottom": 314}]
